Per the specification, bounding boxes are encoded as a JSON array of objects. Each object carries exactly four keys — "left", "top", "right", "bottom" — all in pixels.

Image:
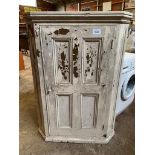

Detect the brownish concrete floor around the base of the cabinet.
[{"left": 19, "top": 57, "right": 135, "bottom": 155}]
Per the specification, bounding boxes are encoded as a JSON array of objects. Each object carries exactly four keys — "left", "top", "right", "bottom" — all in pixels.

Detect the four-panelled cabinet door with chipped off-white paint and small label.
[{"left": 40, "top": 24, "right": 118, "bottom": 138}]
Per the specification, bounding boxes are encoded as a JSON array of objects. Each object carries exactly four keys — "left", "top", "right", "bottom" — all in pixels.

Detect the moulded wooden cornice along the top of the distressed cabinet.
[{"left": 27, "top": 11, "right": 133, "bottom": 23}]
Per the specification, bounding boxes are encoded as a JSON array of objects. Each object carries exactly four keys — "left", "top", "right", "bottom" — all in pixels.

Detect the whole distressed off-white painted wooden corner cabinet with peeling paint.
[{"left": 27, "top": 12, "right": 132, "bottom": 143}]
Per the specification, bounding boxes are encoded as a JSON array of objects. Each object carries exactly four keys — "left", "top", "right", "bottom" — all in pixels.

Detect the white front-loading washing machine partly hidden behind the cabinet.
[{"left": 116, "top": 53, "right": 135, "bottom": 116}]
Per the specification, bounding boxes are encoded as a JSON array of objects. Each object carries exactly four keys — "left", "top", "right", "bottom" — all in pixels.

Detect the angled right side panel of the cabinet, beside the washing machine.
[{"left": 105, "top": 24, "right": 128, "bottom": 135}]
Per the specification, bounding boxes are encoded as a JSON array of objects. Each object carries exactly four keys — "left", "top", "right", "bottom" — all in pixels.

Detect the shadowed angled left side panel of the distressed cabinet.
[{"left": 29, "top": 24, "right": 49, "bottom": 136}]
